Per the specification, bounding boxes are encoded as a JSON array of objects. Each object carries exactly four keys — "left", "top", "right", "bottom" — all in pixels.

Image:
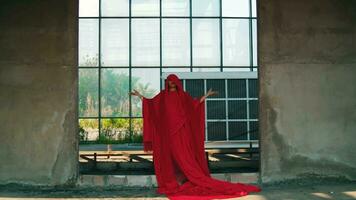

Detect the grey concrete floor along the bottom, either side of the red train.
[{"left": 0, "top": 182, "right": 356, "bottom": 200}]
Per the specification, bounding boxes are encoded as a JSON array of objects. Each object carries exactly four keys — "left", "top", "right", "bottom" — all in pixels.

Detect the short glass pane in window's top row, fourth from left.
[{"left": 162, "top": 0, "right": 189, "bottom": 17}]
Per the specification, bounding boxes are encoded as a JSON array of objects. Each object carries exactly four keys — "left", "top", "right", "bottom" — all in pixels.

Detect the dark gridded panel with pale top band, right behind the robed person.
[{"left": 167, "top": 71, "right": 258, "bottom": 142}]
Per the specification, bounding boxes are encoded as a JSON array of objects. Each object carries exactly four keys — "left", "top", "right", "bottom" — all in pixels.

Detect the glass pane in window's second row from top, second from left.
[{"left": 101, "top": 19, "right": 129, "bottom": 66}]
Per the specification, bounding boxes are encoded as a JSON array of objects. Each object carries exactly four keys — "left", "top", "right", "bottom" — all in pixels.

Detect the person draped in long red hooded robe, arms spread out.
[{"left": 131, "top": 74, "right": 261, "bottom": 200}]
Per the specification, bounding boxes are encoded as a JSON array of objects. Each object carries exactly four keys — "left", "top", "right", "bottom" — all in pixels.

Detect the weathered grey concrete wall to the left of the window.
[{"left": 0, "top": 0, "right": 78, "bottom": 185}]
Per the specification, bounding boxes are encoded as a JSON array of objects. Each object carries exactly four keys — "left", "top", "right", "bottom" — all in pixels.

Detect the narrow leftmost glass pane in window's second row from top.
[{"left": 78, "top": 19, "right": 99, "bottom": 66}]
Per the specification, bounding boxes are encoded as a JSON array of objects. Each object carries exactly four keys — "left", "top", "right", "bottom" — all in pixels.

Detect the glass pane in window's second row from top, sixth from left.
[{"left": 223, "top": 19, "right": 250, "bottom": 66}]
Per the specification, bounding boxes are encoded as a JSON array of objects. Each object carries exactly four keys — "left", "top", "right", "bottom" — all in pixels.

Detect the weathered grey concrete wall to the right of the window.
[{"left": 258, "top": 0, "right": 356, "bottom": 183}]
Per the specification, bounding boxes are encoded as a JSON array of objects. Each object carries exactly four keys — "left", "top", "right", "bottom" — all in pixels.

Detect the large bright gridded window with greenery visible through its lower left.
[{"left": 78, "top": 0, "right": 258, "bottom": 143}]
